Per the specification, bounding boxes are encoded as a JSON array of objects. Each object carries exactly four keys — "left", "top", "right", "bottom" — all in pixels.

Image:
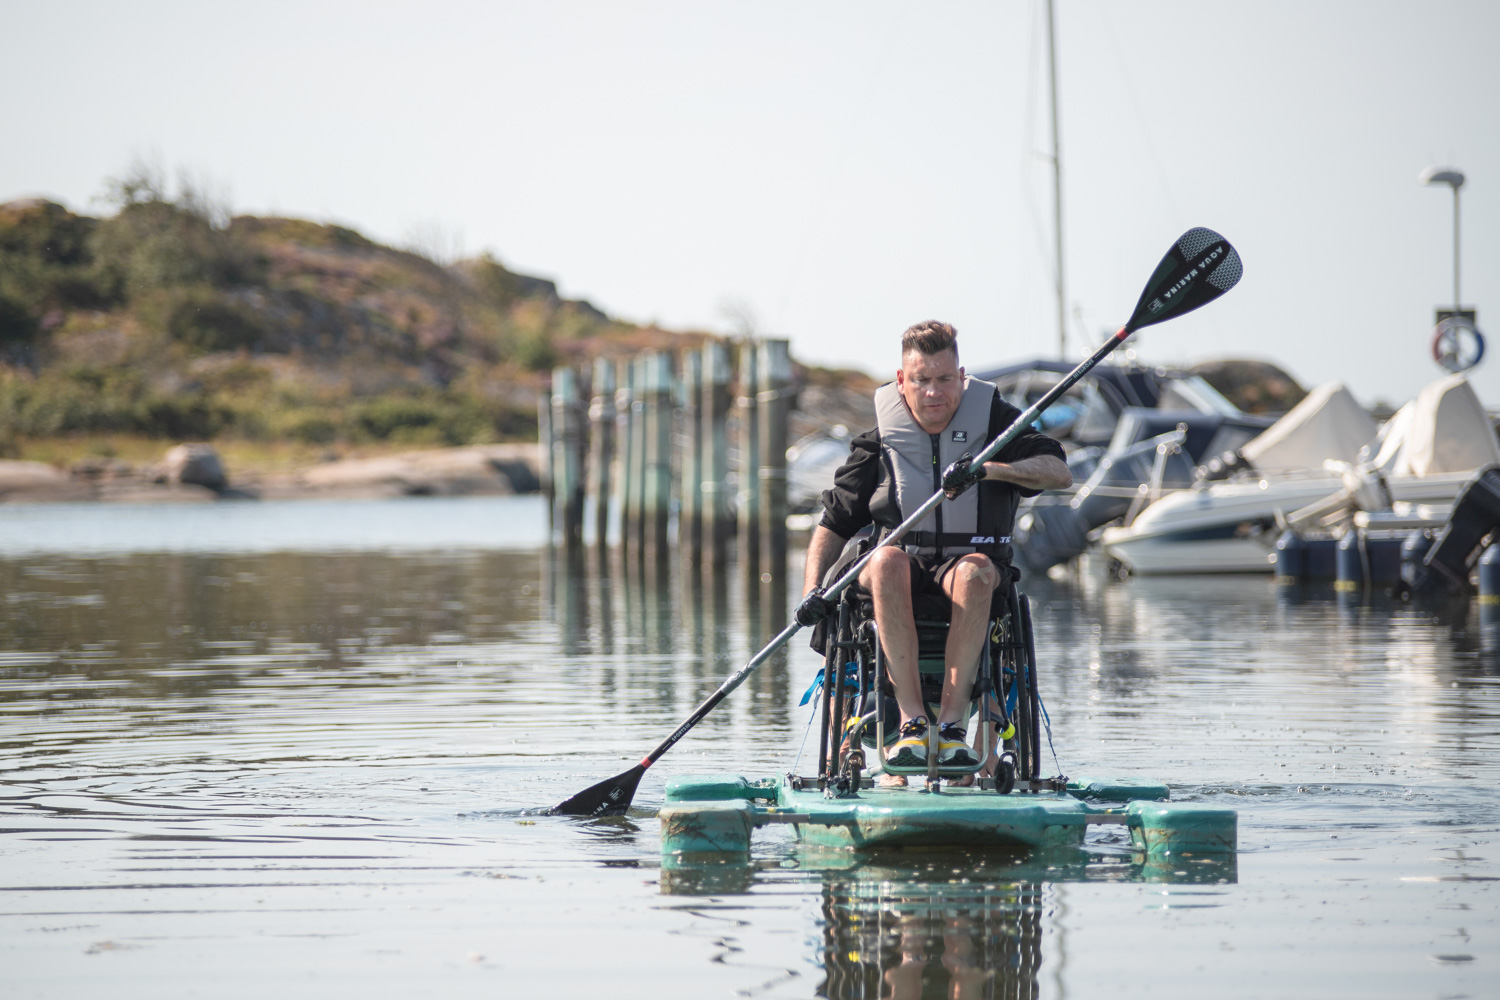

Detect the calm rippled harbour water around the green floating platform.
[{"left": 0, "top": 498, "right": 1500, "bottom": 999}]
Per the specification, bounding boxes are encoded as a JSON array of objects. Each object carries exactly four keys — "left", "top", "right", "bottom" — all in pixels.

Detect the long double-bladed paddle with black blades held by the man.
[{"left": 549, "top": 228, "right": 1242, "bottom": 816}]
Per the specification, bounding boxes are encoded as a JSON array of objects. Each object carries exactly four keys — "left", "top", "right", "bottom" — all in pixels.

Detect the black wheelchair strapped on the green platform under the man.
[{"left": 813, "top": 543, "right": 1044, "bottom": 798}]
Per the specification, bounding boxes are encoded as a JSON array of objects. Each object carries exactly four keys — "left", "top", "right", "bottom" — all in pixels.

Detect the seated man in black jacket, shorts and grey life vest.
[{"left": 797, "top": 321, "right": 1073, "bottom": 781}]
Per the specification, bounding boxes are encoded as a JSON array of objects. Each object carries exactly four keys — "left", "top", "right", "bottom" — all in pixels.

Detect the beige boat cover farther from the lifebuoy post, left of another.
[{"left": 1241, "top": 382, "right": 1374, "bottom": 475}]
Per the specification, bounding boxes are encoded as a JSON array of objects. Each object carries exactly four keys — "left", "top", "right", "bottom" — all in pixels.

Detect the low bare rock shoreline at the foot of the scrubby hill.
[{"left": 0, "top": 444, "right": 542, "bottom": 504}]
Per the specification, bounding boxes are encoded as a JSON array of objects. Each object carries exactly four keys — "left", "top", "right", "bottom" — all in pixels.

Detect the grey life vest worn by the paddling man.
[{"left": 870, "top": 378, "right": 1011, "bottom": 561}]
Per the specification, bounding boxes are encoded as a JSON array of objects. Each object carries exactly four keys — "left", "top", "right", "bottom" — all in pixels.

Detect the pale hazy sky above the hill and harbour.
[{"left": 0, "top": 0, "right": 1500, "bottom": 406}]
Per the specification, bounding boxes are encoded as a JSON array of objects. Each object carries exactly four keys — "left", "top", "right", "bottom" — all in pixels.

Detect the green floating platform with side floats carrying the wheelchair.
[{"left": 659, "top": 775, "right": 1238, "bottom": 856}]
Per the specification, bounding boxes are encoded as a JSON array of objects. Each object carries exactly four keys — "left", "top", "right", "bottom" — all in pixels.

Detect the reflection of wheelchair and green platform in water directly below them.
[{"left": 662, "top": 844, "right": 1238, "bottom": 1000}]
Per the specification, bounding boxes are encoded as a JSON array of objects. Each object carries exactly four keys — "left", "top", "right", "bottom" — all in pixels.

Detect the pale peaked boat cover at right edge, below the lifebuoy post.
[{"left": 1374, "top": 375, "right": 1500, "bottom": 475}]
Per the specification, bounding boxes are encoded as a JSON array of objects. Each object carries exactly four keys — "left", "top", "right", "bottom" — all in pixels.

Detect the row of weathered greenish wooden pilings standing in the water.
[{"left": 537, "top": 339, "right": 794, "bottom": 577}]
